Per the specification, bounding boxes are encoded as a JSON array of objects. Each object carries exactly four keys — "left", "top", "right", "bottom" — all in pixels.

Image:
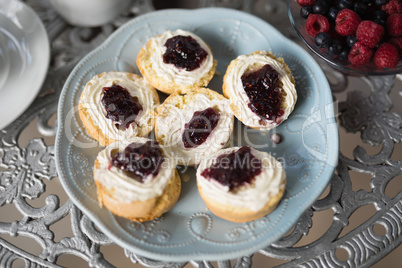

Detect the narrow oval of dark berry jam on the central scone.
[{"left": 182, "top": 108, "right": 220, "bottom": 148}]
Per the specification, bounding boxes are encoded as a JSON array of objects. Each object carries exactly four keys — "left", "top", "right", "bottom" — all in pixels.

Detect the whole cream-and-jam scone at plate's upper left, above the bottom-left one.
[{"left": 78, "top": 72, "right": 160, "bottom": 146}]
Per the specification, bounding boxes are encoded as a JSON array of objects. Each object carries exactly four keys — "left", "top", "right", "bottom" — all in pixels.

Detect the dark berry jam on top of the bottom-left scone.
[{"left": 111, "top": 141, "right": 164, "bottom": 182}]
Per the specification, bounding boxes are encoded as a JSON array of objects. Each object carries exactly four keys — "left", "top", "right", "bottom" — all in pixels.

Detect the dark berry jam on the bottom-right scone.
[{"left": 201, "top": 146, "right": 262, "bottom": 191}]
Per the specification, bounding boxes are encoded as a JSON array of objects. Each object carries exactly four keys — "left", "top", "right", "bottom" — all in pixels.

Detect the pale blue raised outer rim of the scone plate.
[{"left": 55, "top": 7, "right": 339, "bottom": 262}]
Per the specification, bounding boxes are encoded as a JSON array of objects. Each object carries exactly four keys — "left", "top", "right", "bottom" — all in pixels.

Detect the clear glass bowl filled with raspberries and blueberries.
[{"left": 288, "top": 0, "right": 402, "bottom": 75}]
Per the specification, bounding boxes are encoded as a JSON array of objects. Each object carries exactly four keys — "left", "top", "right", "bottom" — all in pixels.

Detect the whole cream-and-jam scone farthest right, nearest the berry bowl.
[{"left": 223, "top": 51, "right": 297, "bottom": 130}]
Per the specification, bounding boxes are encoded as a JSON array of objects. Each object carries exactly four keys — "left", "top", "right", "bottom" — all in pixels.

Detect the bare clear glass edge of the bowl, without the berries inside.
[{"left": 287, "top": 0, "right": 402, "bottom": 75}]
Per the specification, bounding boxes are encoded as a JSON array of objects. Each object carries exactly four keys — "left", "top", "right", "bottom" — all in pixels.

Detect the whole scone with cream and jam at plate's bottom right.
[{"left": 196, "top": 146, "right": 286, "bottom": 222}]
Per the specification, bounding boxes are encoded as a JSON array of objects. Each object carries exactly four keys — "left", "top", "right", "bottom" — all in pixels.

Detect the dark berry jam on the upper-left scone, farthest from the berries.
[{"left": 101, "top": 85, "right": 142, "bottom": 130}]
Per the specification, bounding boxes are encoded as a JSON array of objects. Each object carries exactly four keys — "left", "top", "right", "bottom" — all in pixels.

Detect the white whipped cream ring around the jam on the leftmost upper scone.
[{"left": 80, "top": 72, "right": 159, "bottom": 140}]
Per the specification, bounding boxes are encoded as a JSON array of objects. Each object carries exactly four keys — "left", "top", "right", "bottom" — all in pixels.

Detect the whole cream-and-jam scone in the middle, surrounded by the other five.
[{"left": 155, "top": 88, "right": 234, "bottom": 166}]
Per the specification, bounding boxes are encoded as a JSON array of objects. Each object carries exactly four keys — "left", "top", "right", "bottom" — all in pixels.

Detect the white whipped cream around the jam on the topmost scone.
[{"left": 144, "top": 29, "right": 214, "bottom": 86}]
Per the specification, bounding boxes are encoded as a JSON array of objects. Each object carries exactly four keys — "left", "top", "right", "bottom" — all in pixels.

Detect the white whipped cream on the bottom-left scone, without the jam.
[{"left": 94, "top": 137, "right": 176, "bottom": 203}]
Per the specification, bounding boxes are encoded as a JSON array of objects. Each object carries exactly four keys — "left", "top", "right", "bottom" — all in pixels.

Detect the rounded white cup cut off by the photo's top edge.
[{"left": 50, "top": 0, "right": 132, "bottom": 27}]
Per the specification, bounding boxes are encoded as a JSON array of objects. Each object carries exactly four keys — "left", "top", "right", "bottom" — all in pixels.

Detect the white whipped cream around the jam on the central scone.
[{"left": 155, "top": 92, "right": 234, "bottom": 165}]
